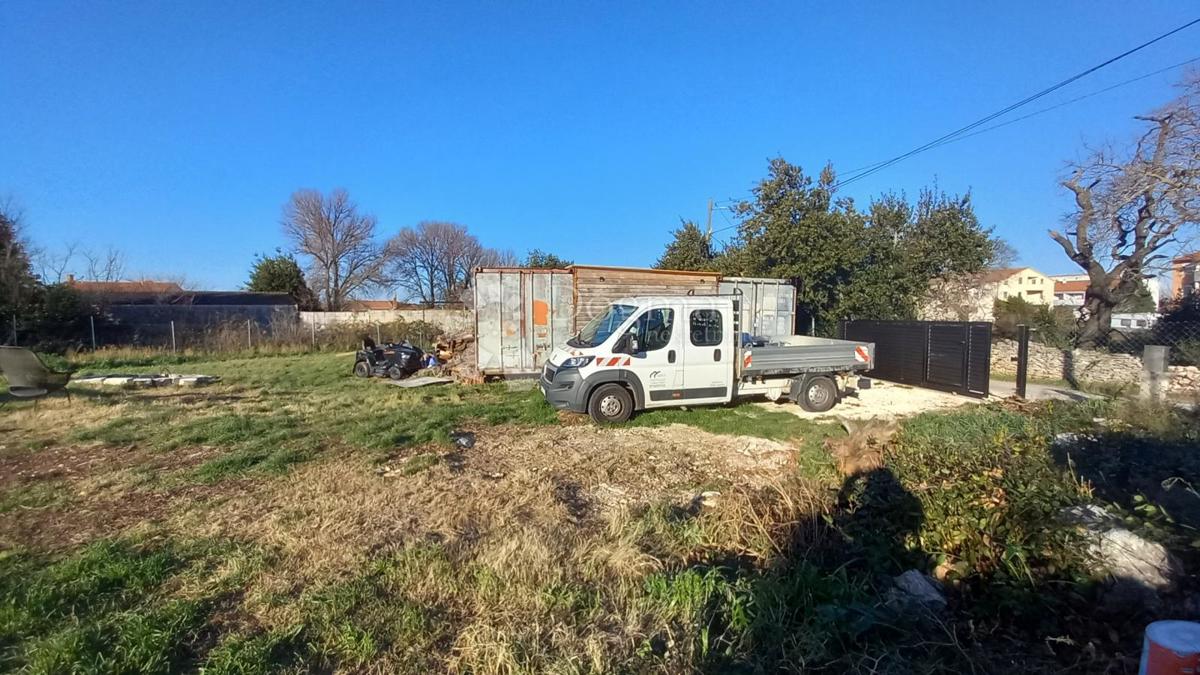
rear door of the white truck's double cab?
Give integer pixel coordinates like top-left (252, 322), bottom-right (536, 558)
top-left (680, 307), bottom-right (737, 404)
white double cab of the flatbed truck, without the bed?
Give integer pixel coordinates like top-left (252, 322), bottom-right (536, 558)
top-left (541, 295), bottom-right (738, 422)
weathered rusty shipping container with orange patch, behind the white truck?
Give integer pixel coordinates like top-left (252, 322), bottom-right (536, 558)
top-left (474, 265), bottom-right (796, 376)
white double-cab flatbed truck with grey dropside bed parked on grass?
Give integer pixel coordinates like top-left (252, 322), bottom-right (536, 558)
top-left (540, 295), bottom-right (875, 423)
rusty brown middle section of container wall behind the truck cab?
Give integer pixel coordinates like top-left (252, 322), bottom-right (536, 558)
top-left (572, 267), bottom-right (719, 330)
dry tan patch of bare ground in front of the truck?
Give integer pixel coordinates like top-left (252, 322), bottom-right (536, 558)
top-left (173, 425), bottom-right (794, 585)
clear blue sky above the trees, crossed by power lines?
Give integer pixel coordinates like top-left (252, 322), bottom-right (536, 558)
top-left (0, 0), bottom-right (1200, 288)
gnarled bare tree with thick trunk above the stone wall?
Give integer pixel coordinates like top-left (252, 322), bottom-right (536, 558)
top-left (1050, 74), bottom-right (1200, 347)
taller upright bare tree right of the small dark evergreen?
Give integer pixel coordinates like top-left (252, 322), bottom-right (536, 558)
top-left (283, 189), bottom-right (385, 310)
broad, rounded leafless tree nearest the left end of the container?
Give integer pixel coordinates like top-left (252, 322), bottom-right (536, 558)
top-left (388, 221), bottom-right (516, 306)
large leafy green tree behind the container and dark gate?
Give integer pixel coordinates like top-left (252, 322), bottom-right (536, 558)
top-left (715, 159), bottom-right (995, 333)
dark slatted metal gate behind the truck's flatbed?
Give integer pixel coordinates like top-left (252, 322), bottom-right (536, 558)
top-left (839, 321), bottom-right (991, 398)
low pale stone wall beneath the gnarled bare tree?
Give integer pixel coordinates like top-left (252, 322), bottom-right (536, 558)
top-left (991, 340), bottom-right (1200, 394)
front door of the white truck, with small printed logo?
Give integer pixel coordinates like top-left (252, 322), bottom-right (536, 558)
top-left (624, 307), bottom-right (684, 408)
